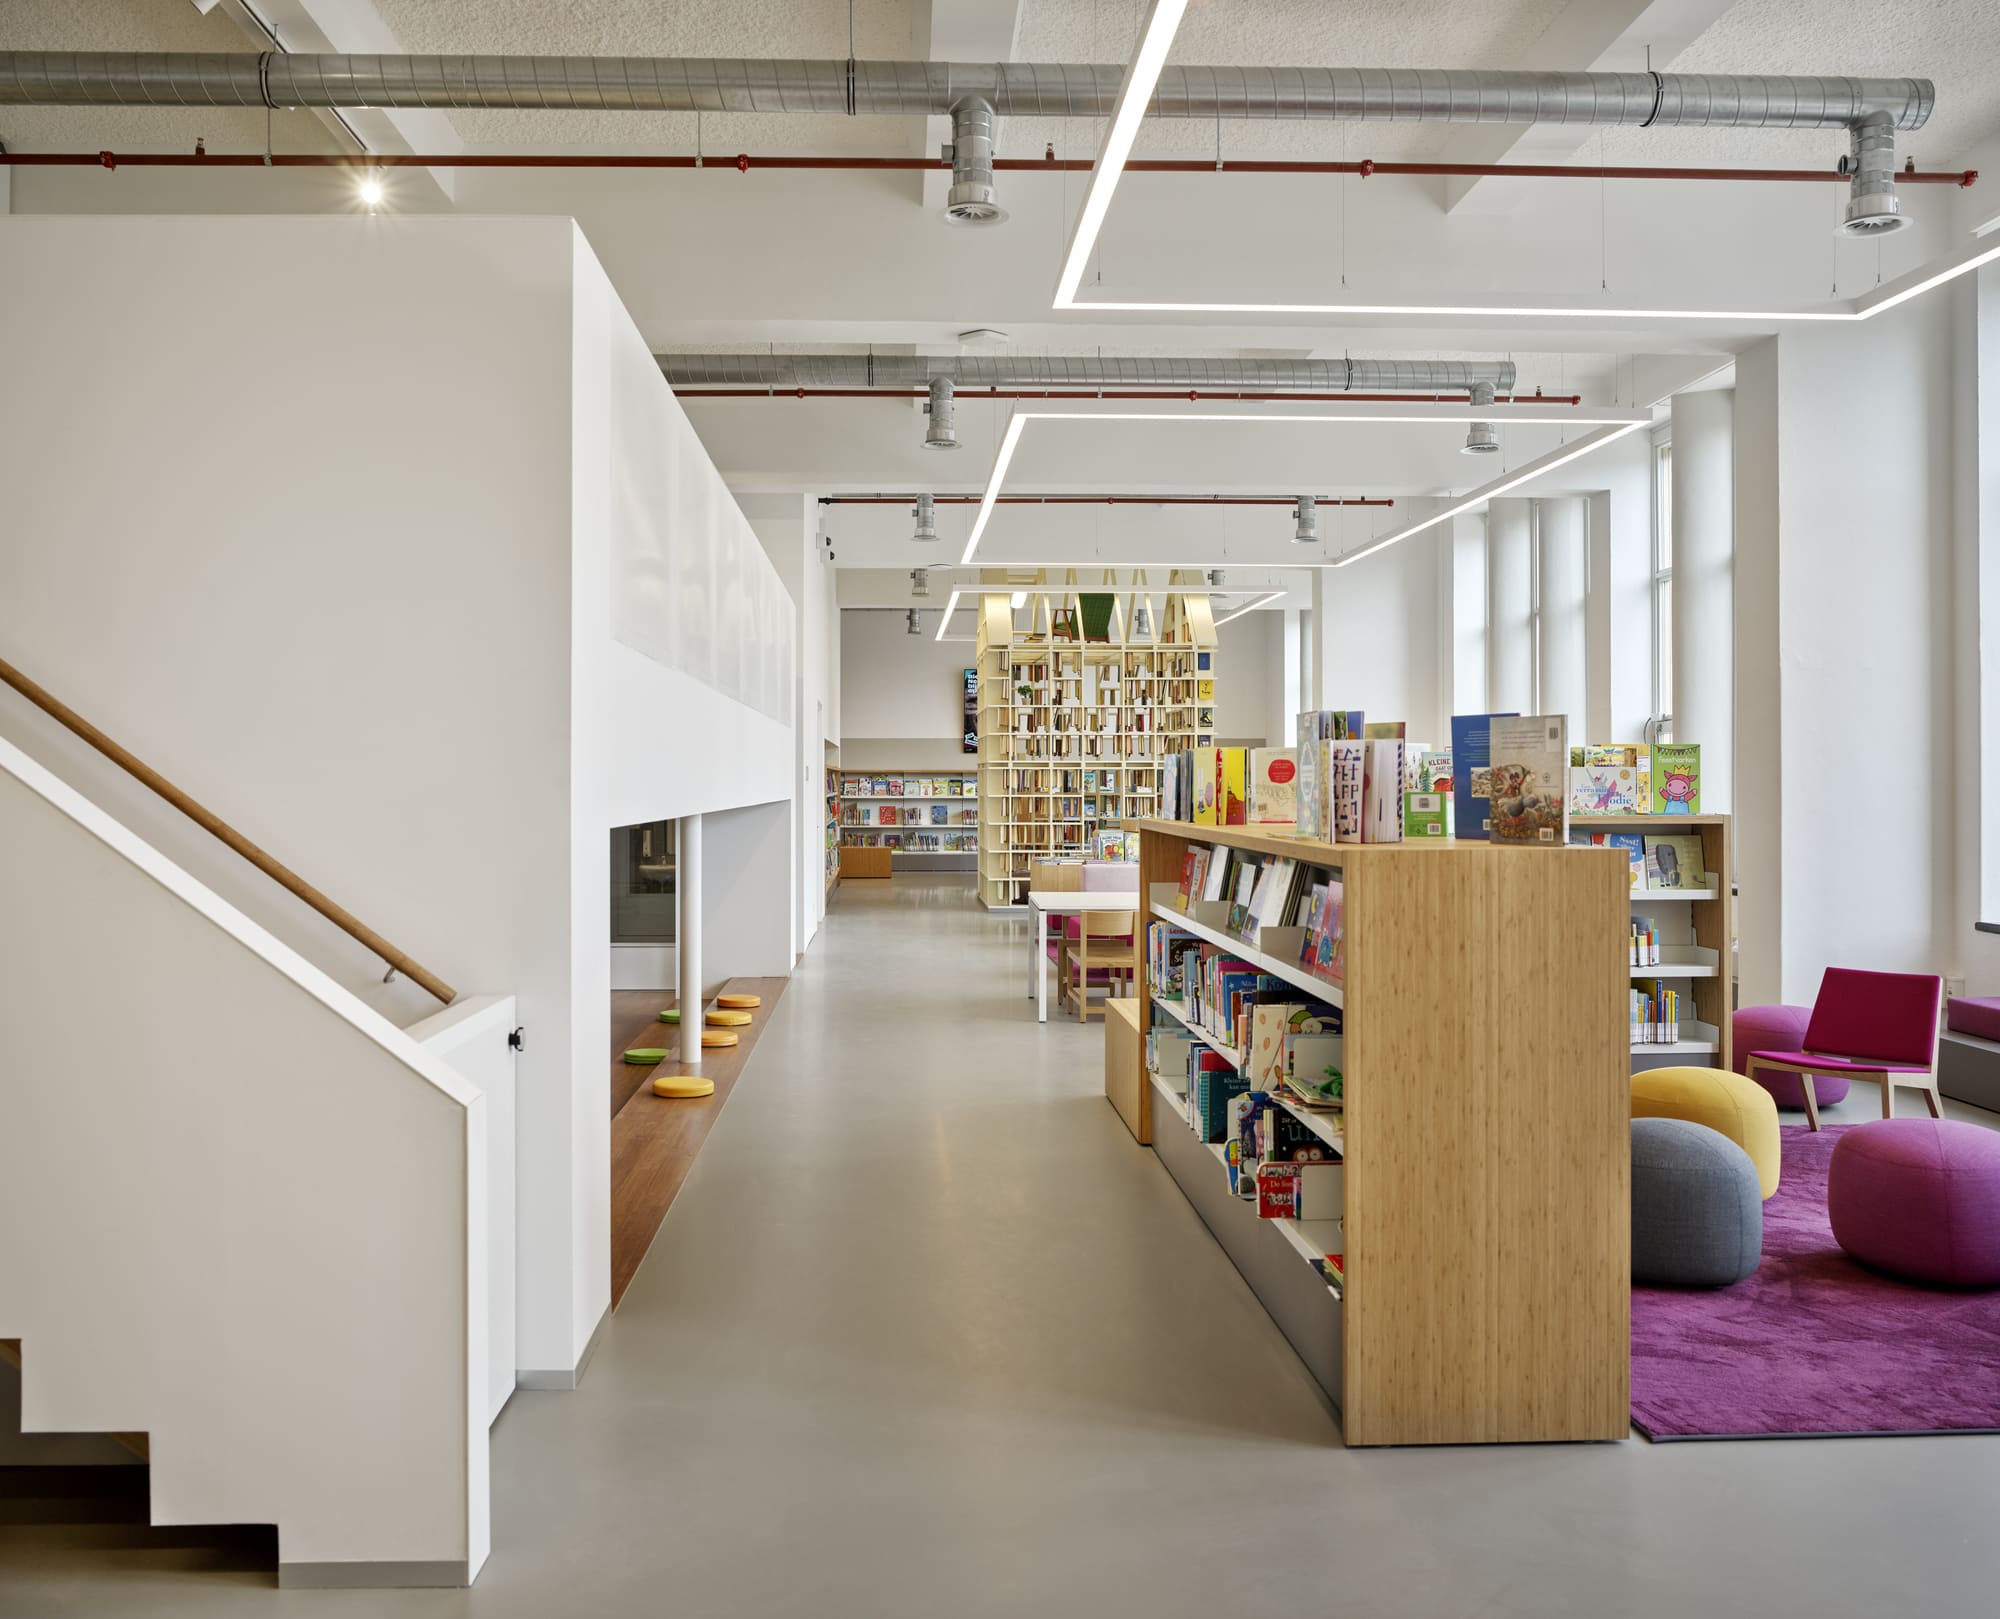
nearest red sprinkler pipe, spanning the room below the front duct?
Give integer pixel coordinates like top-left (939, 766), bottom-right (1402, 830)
top-left (0, 150), bottom-right (1980, 188)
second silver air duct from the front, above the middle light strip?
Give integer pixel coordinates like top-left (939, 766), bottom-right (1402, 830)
top-left (658, 354), bottom-right (1514, 391)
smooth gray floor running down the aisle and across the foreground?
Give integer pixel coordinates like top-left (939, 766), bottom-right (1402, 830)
top-left (11, 879), bottom-right (2000, 1619)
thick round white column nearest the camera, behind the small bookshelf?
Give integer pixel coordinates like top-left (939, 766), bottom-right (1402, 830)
top-left (1674, 388), bottom-right (1736, 811)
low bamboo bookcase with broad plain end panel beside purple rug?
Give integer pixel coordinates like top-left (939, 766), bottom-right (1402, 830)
top-left (1106, 819), bottom-right (1632, 1445)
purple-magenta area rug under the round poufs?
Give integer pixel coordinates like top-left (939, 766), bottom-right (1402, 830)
top-left (1632, 1125), bottom-right (2000, 1439)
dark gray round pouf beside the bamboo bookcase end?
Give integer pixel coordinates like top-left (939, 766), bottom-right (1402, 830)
top-left (1632, 1119), bottom-right (1764, 1287)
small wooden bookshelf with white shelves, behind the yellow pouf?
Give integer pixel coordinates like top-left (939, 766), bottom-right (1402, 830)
top-left (1570, 815), bottom-right (1736, 1067)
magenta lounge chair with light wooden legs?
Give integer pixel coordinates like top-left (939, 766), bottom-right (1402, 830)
top-left (1744, 967), bottom-right (1944, 1129)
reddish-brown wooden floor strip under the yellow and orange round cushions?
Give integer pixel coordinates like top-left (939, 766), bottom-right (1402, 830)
top-left (610, 977), bottom-right (786, 1309)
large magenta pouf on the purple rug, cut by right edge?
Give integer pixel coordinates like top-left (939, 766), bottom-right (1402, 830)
top-left (1826, 1119), bottom-right (2000, 1287)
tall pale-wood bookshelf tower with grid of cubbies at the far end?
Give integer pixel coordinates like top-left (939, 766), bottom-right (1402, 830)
top-left (978, 572), bottom-right (1216, 909)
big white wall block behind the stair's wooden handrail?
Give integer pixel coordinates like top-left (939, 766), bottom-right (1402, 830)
top-left (0, 216), bottom-right (792, 1383)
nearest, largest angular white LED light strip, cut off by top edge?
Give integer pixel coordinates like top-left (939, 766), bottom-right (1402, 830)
top-left (1056, 0), bottom-right (2000, 320)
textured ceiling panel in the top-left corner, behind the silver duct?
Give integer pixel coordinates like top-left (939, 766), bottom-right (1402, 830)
top-left (0, 0), bottom-right (340, 152)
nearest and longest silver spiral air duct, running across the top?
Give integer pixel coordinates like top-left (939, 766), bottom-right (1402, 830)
top-left (0, 50), bottom-right (1936, 130)
